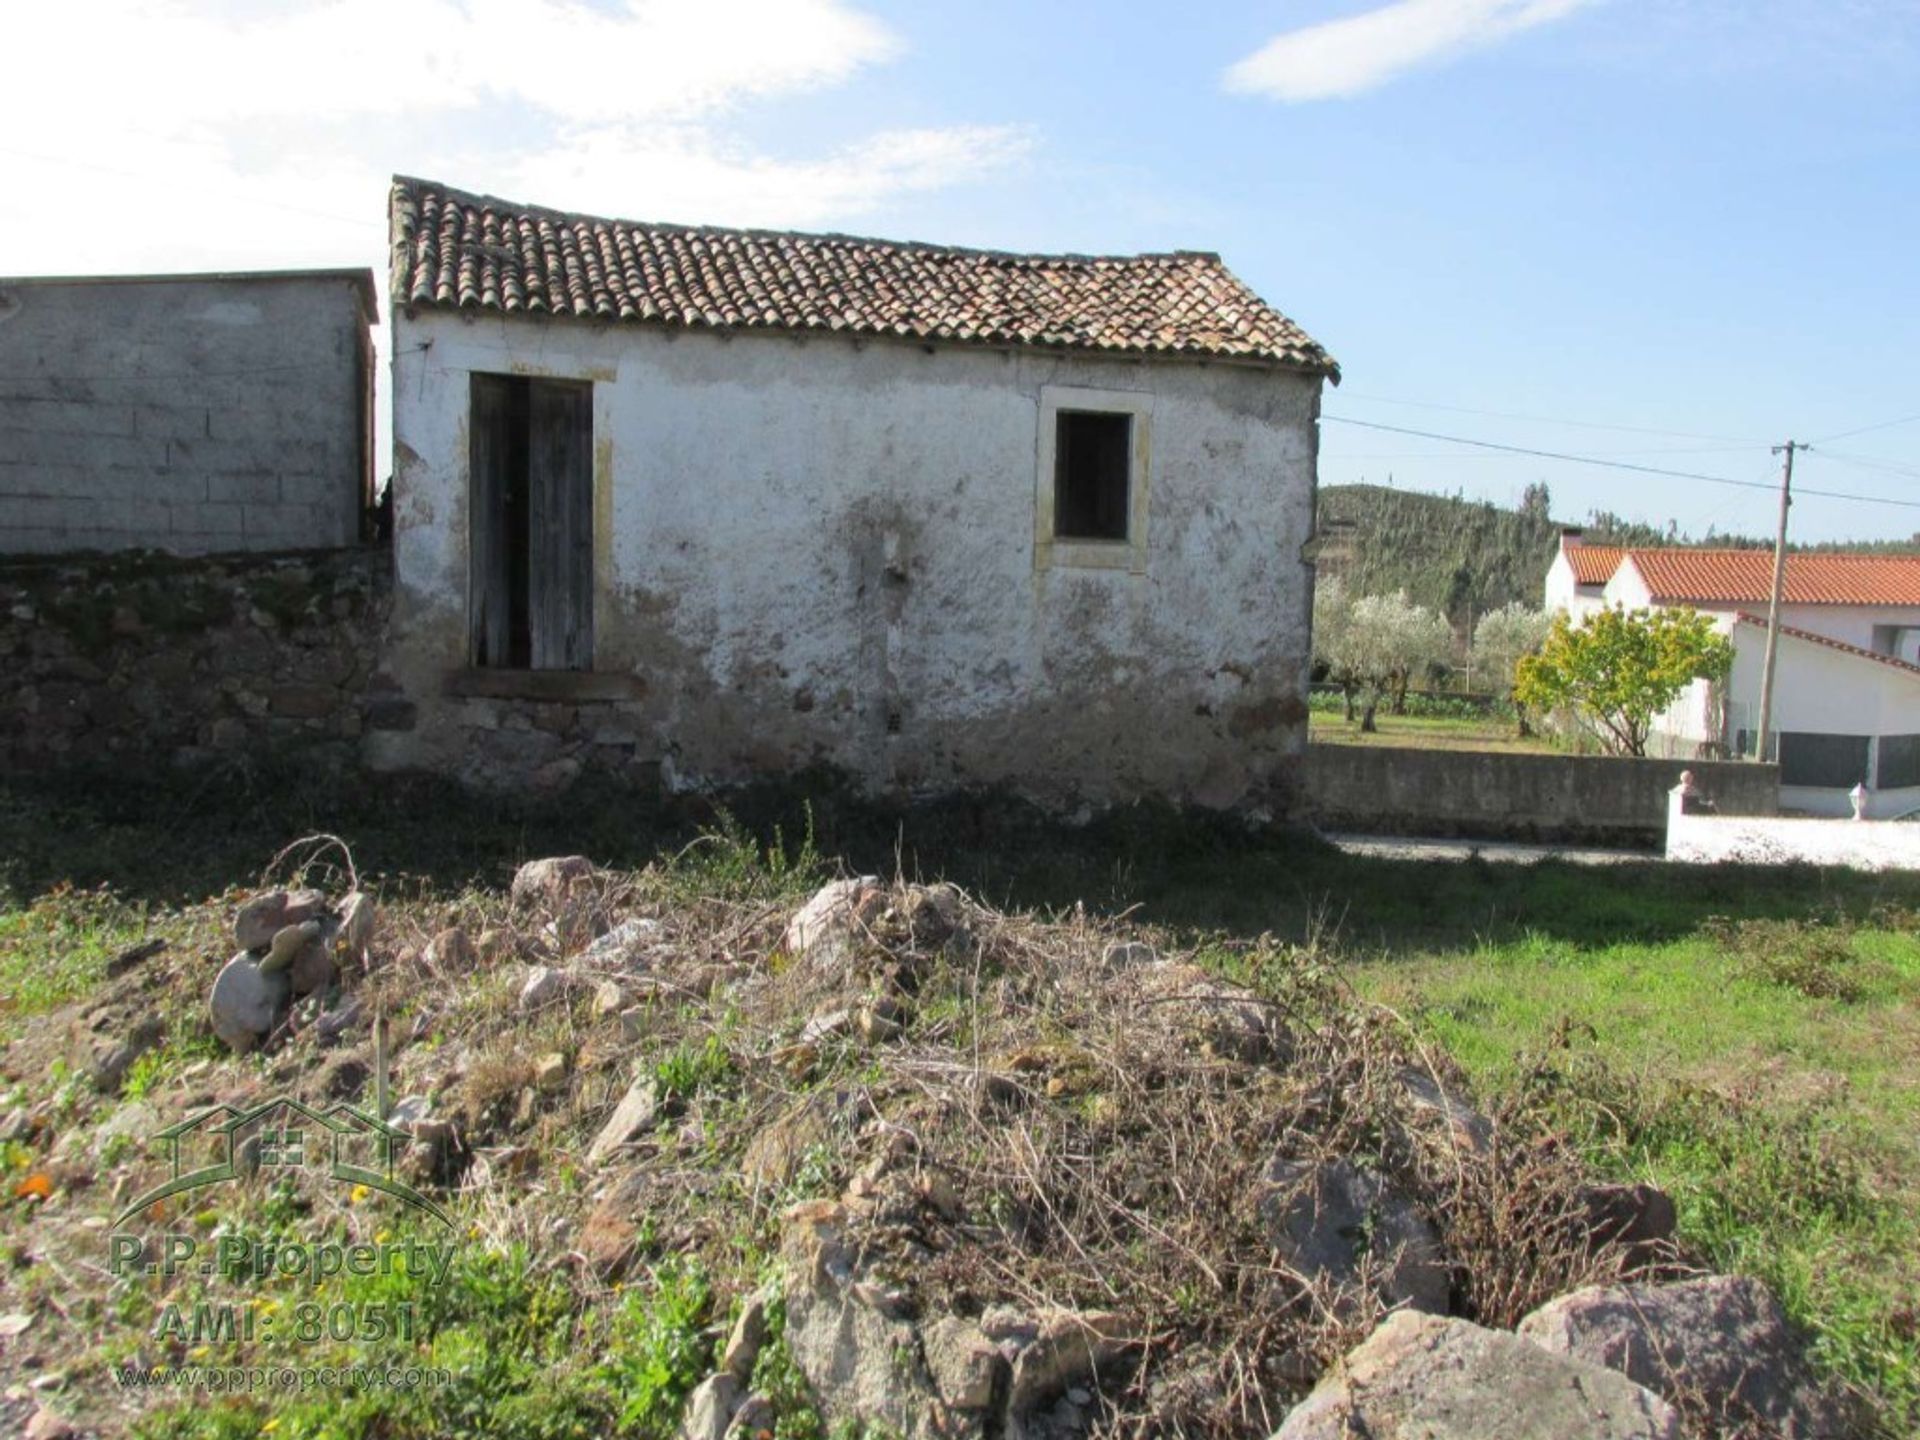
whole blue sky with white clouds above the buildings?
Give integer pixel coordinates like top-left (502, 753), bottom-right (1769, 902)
top-left (0, 0), bottom-right (1920, 540)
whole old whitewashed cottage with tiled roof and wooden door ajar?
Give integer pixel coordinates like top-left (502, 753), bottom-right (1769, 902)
top-left (369, 179), bottom-right (1338, 810)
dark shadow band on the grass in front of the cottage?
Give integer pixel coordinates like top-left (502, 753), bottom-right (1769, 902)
top-left (0, 764), bottom-right (1920, 952)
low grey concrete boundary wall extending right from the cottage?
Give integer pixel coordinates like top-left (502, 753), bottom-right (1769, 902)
top-left (1308, 745), bottom-right (1780, 849)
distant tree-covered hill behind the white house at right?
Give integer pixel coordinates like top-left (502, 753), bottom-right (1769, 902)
top-left (1319, 486), bottom-right (1920, 636)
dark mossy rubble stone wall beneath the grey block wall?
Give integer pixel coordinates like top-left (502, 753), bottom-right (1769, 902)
top-left (0, 549), bottom-right (389, 772)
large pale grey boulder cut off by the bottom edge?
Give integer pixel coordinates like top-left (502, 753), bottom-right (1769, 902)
top-left (1273, 1309), bottom-right (1682, 1440)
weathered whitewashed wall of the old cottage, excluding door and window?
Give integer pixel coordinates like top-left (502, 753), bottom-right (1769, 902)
top-left (372, 311), bottom-right (1319, 806)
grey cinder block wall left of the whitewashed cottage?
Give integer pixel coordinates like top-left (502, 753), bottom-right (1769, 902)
top-left (0, 269), bottom-right (378, 555)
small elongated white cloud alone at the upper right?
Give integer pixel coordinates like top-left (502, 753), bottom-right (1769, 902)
top-left (1225, 0), bottom-right (1594, 100)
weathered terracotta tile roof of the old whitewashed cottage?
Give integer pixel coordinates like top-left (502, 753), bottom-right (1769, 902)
top-left (390, 177), bottom-right (1340, 382)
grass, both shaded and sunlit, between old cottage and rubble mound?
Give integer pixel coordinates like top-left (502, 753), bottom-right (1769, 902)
top-left (11, 768), bottom-right (1920, 1434)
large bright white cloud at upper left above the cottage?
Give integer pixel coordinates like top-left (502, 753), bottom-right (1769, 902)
top-left (0, 0), bottom-right (1029, 273)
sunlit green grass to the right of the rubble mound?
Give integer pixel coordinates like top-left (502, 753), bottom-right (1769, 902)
top-left (1354, 910), bottom-right (1920, 1434)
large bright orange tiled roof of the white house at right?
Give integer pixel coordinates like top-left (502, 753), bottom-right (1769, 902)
top-left (1628, 549), bottom-right (1920, 605)
